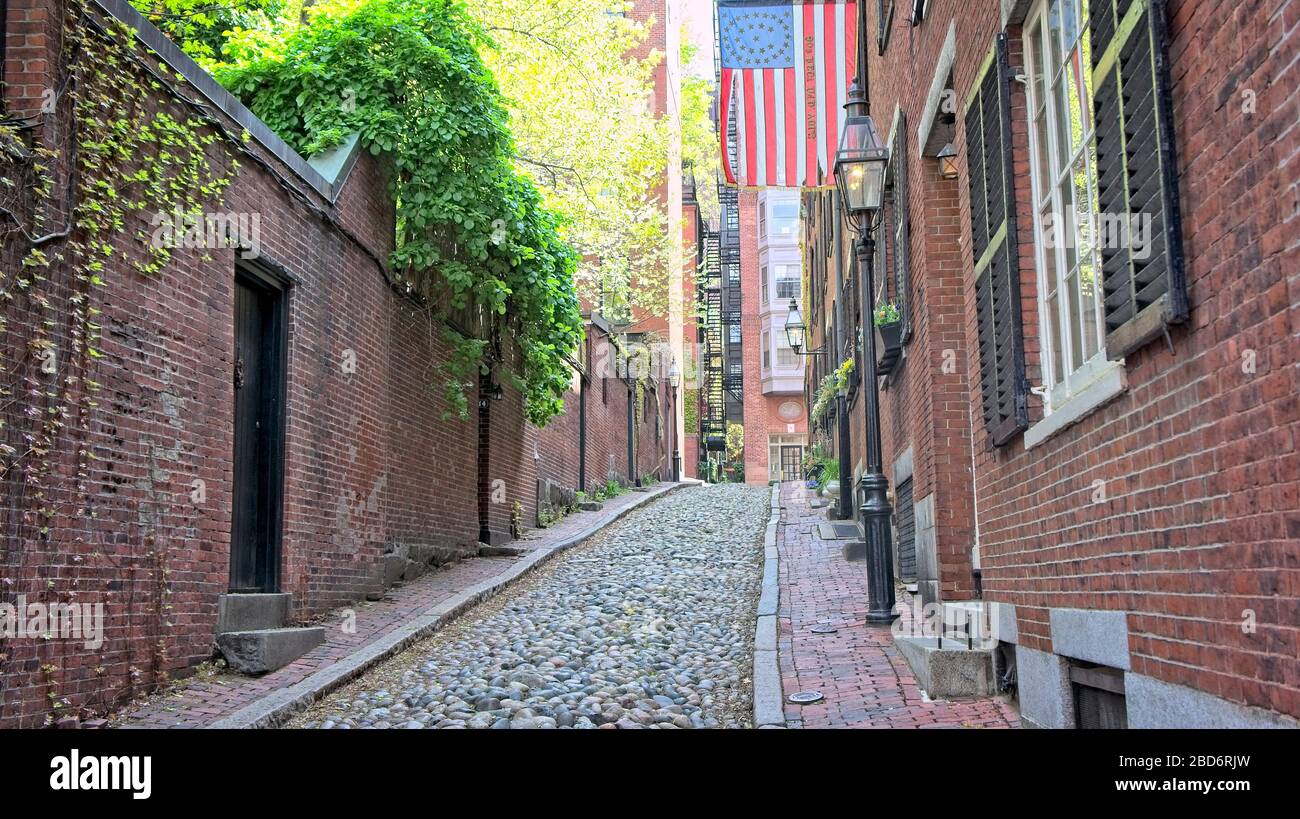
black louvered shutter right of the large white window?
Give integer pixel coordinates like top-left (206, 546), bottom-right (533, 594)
top-left (1089, 0), bottom-right (1188, 359)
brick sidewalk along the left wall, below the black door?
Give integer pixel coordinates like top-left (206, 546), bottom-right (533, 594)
top-left (112, 484), bottom-right (668, 728)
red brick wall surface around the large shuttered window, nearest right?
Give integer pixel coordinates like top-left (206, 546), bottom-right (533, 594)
top-left (927, 0), bottom-right (1300, 715)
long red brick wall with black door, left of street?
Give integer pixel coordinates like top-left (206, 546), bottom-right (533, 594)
top-left (0, 0), bottom-right (672, 725)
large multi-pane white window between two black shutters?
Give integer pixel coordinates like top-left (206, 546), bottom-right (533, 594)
top-left (1024, 0), bottom-right (1106, 412)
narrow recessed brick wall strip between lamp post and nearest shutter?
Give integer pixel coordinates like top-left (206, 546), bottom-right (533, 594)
top-left (845, 3), bottom-right (977, 601)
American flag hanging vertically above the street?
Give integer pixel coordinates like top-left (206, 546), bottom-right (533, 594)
top-left (718, 0), bottom-right (858, 187)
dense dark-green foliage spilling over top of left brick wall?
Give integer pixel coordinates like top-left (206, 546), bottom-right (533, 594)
top-left (165, 0), bottom-right (582, 425)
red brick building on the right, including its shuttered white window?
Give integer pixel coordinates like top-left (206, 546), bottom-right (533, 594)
top-left (805, 0), bottom-right (1300, 727)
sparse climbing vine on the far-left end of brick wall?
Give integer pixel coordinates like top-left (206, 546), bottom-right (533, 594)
top-left (0, 0), bottom-right (238, 712)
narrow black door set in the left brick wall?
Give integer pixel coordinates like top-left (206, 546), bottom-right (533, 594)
top-left (230, 274), bottom-right (285, 592)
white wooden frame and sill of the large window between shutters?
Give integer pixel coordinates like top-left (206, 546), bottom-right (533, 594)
top-left (1021, 0), bottom-right (1115, 413)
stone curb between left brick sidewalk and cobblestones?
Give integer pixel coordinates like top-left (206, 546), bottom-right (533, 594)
top-left (207, 484), bottom-right (686, 728)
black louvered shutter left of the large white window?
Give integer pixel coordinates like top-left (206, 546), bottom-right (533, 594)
top-left (965, 34), bottom-right (1030, 446)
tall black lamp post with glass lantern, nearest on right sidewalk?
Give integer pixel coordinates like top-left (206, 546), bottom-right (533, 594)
top-left (835, 82), bottom-right (897, 624)
